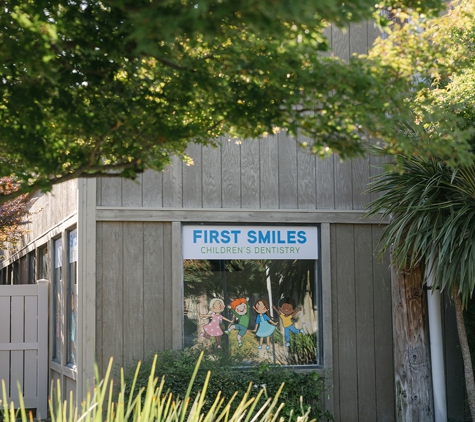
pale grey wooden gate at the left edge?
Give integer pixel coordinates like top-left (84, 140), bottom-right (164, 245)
top-left (0, 280), bottom-right (49, 419)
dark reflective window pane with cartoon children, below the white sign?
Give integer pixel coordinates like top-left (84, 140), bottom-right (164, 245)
top-left (184, 259), bottom-right (320, 365)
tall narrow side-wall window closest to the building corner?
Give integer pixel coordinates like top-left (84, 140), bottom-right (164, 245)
top-left (66, 229), bottom-right (78, 366)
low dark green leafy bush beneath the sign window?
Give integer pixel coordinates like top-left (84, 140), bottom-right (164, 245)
top-left (121, 348), bottom-right (333, 421)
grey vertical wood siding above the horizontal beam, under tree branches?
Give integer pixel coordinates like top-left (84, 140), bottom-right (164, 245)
top-left (97, 132), bottom-right (390, 210)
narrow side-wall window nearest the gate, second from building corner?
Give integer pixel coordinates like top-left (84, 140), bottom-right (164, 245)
top-left (53, 238), bottom-right (63, 362)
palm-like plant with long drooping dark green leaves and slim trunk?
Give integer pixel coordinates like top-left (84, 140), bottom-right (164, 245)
top-left (368, 157), bottom-right (475, 415)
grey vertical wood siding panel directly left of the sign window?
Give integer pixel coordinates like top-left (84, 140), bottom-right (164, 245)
top-left (96, 222), bottom-right (183, 371)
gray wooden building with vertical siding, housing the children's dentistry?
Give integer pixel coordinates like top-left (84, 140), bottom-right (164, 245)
top-left (0, 20), bottom-right (464, 422)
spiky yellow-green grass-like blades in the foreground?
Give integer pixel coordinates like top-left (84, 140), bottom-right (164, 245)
top-left (0, 354), bottom-right (328, 422)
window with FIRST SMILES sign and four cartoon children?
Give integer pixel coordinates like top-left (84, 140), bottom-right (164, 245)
top-left (183, 225), bottom-right (322, 365)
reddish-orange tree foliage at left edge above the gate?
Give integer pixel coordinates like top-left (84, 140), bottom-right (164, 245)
top-left (0, 177), bottom-right (31, 254)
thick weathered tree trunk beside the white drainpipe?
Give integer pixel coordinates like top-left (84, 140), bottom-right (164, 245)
top-left (391, 267), bottom-right (434, 422)
